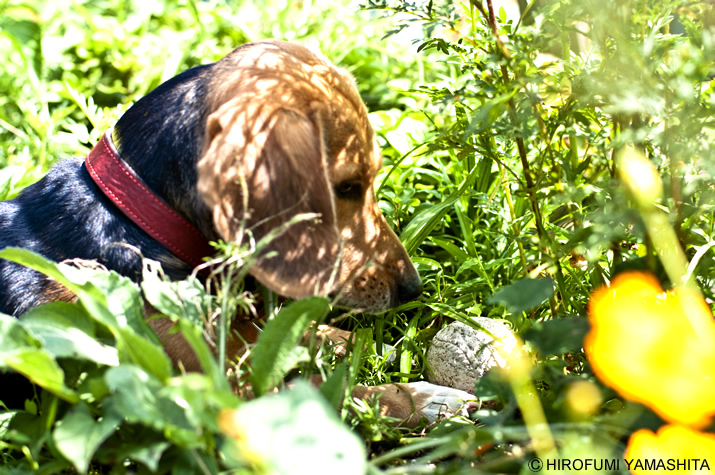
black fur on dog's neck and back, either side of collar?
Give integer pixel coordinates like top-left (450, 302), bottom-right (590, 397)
top-left (0, 61), bottom-right (224, 316)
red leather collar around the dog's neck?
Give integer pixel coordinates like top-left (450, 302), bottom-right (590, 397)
top-left (84, 131), bottom-right (215, 267)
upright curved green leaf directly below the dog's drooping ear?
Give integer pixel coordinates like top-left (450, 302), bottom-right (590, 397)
top-left (251, 297), bottom-right (329, 395)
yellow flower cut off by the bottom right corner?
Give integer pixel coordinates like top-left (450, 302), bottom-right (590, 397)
top-left (623, 425), bottom-right (715, 475)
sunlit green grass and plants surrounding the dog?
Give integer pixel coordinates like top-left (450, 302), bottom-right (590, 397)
top-left (0, 0), bottom-right (715, 473)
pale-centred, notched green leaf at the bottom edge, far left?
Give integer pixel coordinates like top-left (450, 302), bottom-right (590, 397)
top-left (52, 403), bottom-right (122, 473)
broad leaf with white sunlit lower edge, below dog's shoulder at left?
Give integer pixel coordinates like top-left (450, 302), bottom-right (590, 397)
top-left (21, 302), bottom-right (119, 366)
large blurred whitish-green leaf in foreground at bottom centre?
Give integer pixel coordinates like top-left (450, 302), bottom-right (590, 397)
top-left (220, 381), bottom-right (367, 475)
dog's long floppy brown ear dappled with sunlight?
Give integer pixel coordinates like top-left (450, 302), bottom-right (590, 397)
top-left (198, 98), bottom-right (339, 298)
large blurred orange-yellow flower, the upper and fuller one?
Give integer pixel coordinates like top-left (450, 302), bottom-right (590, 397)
top-left (584, 272), bottom-right (715, 427)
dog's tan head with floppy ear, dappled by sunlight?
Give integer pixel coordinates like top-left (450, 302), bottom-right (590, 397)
top-left (198, 41), bottom-right (422, 313)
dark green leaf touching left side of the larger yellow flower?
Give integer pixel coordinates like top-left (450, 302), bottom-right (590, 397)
top-left (524, 318), bottom-right (590, 358)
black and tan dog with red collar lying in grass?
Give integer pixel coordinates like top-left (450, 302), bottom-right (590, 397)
top-left (0, 40), bottom-right (482, 425)
